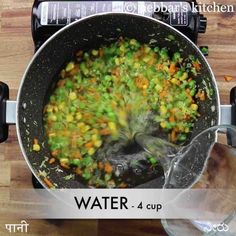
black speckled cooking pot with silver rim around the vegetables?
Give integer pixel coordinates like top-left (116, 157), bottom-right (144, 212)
top-left (0, 13), bottom-right (234, 188)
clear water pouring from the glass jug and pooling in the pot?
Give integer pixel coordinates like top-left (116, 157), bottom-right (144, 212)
top-left (97, 96), bottom-right (236, 189)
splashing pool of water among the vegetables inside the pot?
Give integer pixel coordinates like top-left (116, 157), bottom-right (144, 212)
top-left (97, 107), bottom-right (164, 188)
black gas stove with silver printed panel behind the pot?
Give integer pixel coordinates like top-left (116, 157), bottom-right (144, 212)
top-left (32, 0), bottom-right (207, 188)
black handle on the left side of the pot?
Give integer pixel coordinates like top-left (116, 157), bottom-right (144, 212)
top-left (0, 82), bottom-right (9, 143)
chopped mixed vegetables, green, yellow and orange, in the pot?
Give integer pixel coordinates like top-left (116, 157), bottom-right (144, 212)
top-left (43, 39), bottom-right (205, 187)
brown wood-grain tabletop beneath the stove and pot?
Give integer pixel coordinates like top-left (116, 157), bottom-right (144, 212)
top-left (0, 0), bottom-right (236, 236)
